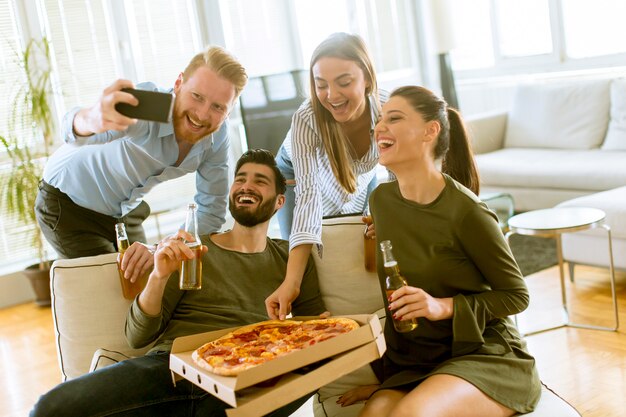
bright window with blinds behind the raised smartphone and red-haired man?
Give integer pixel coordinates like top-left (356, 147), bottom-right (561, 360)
top-left (43, 0), bottom-right (201, 110)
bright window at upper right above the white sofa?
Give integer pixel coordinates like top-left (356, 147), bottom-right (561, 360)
top-left (450, 0), bottom-right (626, 78)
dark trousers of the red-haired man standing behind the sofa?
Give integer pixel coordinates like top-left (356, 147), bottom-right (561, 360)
top-left (35, 180), bottom-right (150, 258)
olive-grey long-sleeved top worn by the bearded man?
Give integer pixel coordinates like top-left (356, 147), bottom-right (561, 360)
top-left (126, 236), bottom-right (325, 352)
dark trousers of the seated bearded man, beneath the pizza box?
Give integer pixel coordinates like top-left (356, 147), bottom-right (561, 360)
top-left (30, 352), bottom-right (310, 417)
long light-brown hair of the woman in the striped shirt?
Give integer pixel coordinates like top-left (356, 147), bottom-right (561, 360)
top-left (309, 32), bottom-right (380, 194)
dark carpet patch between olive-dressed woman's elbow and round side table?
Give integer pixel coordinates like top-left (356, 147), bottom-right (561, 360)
top-left (509, 235), bottom-right (558, 276)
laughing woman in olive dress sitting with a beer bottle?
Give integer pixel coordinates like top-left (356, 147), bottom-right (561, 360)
top-left (339, 86), bottom-right (541, 417)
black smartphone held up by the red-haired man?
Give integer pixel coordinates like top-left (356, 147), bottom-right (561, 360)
top-left (115, 88), bottom-right (174, 123)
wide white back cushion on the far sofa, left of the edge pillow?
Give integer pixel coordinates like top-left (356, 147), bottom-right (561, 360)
top-left (504, 80), bottom-right (610, 149)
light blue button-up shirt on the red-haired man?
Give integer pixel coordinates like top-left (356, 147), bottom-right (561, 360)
top-left (43, 83), bottom-right (230, 234)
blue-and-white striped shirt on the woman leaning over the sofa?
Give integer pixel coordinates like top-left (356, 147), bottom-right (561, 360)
top-left (283, 91), bottom-right (387, 253)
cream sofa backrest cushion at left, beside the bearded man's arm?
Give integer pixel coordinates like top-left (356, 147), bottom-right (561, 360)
top-left (50, 253), bottom-right (148, 380)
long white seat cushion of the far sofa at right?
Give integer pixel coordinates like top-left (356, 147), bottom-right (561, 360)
top-left (476, 148), bottom-right (626, 192)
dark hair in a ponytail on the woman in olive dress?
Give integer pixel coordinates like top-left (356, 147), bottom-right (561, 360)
top-left (390, 86), bottom-right (480, 195)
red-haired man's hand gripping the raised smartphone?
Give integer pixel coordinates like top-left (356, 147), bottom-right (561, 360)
top-left (72, 79), bottom-right (139, 136)
